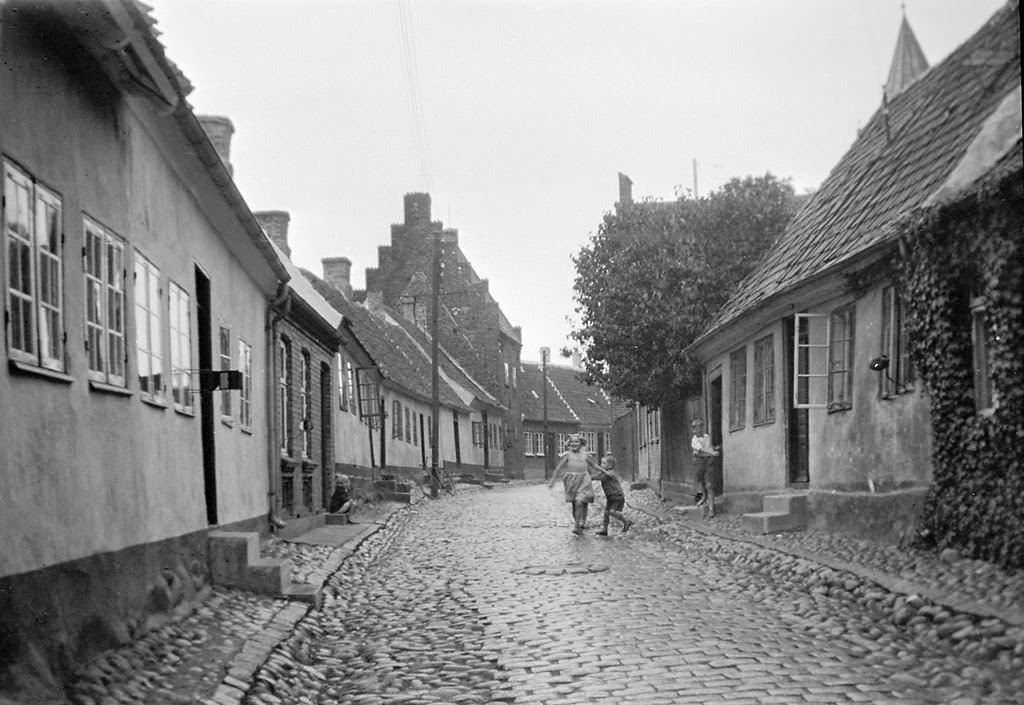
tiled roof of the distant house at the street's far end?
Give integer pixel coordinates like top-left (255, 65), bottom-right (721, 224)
top-left (519, 362), bottom-right (625, 427)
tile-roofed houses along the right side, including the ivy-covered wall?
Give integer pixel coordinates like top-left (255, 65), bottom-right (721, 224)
top-left (616, 0), bottom-right (1024, 549)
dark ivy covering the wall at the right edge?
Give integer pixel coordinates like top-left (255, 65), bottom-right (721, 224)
top-left (899, 172), bottom-right (1024, 568)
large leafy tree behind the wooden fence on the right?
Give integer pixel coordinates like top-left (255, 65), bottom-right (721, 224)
top-left (571, 174), bottom-right (798, 407)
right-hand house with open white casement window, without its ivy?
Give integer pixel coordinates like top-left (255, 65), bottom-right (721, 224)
top-left (692, 3), bottom-right (1020, 538)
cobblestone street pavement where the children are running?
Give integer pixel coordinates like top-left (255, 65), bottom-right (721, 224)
top-left (71, 485), bottom-right (1024, 705)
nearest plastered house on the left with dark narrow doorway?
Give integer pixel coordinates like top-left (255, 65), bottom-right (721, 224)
top-left (0, 0), bottom-right (288, 689)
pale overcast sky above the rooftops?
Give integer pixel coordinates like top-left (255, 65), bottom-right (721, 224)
top-left (147, 0), bottom-right (1004, 363)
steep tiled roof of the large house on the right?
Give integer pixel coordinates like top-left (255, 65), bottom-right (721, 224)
top-left (700, 0), bottom-right (1021, 340)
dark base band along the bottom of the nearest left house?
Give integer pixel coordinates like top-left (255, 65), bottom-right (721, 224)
top-left (0, 514), bottom-right (268, 702)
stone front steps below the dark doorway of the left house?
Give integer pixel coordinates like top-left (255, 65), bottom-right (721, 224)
top-left (209, 531), bottom-right (319, 604)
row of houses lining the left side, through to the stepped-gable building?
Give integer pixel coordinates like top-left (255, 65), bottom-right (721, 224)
top-left (0, 0), bottom-right (544, 692)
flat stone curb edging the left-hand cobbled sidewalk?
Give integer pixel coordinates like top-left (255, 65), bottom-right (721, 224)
top-left (205, 506), bottom-right (406, 705)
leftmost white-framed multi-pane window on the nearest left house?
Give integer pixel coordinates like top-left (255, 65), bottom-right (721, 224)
top-left (4, 163), bottom-right (65, 371)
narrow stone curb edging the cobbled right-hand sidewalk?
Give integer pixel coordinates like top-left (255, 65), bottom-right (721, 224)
top-left (651, 512), bottom-right (1024, 627)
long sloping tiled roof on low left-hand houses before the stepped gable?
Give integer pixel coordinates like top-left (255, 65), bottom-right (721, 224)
top-left (301, 269), bottom-right (470, 412)
